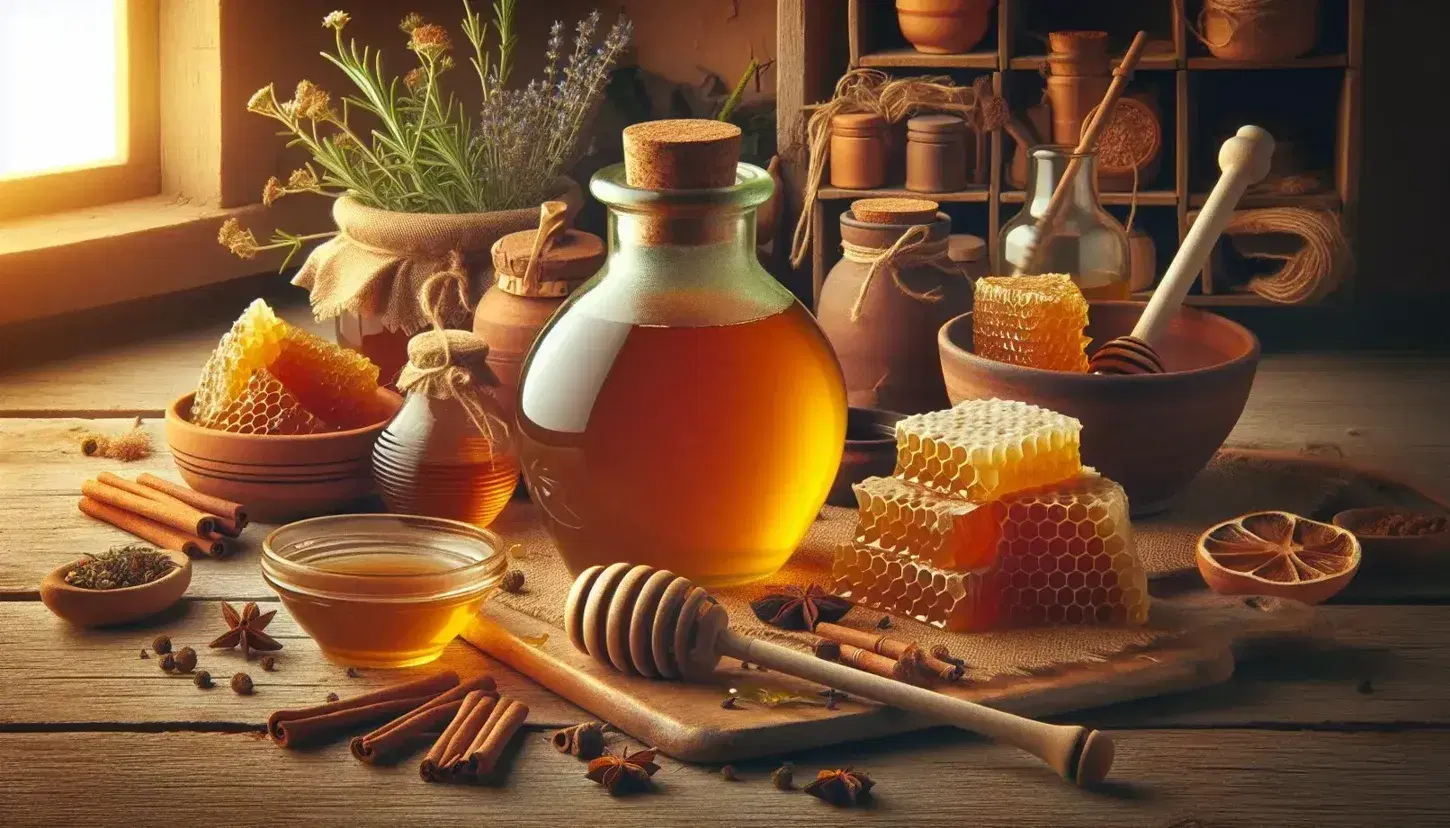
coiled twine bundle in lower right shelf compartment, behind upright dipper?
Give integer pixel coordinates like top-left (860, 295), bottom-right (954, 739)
top-left (1224, 207), bottom-right (1353, 305)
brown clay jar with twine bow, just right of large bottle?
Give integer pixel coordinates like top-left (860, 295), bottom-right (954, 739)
top-left (816, 199), bottom-right (972, 413)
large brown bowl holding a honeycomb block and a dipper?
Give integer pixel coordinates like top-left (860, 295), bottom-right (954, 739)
top-left (937, 302), bottom-right (1259, 515)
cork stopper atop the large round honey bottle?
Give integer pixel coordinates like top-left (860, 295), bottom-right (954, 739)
top-left (624, 119), bottom-right (741, 190)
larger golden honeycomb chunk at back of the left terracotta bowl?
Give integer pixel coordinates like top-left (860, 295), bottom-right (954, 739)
top-left (191, 299), bottom-right (387, 434)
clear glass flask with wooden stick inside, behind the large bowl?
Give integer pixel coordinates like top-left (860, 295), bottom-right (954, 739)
top-left (998, 146), bottom-right (1131, 299)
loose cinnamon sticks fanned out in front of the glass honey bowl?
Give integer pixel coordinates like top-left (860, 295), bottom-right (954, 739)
top-left (267, 670), bottom-right (529, 782)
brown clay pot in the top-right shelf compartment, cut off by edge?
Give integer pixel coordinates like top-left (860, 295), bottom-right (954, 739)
top-left (1199, 0), bottom-right (1320, 61)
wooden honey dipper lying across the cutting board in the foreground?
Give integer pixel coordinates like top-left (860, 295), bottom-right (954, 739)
top-left (564, 564), bottom-right (1114, 787)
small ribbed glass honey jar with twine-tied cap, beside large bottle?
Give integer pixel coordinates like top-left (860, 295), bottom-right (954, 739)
top-left (373, 331), bottom-right (519, 528)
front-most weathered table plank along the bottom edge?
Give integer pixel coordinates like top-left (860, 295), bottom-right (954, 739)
top-left (0, 729), bottom-right (1450, 828)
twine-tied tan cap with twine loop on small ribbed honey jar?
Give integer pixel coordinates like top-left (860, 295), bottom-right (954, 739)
top-left (397, 271), bottom-right (509, 442)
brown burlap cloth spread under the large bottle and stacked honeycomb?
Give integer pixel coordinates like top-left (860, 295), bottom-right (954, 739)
top-left (490, 454), bottom-right (1347, 682)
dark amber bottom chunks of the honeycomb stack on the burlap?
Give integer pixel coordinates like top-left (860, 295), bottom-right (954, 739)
top-left (832, 471), bottom-right (1148, 632)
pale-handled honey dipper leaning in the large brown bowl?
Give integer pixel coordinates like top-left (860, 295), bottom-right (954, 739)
top-left (1088, 126), bottom-right (1273, 374)
